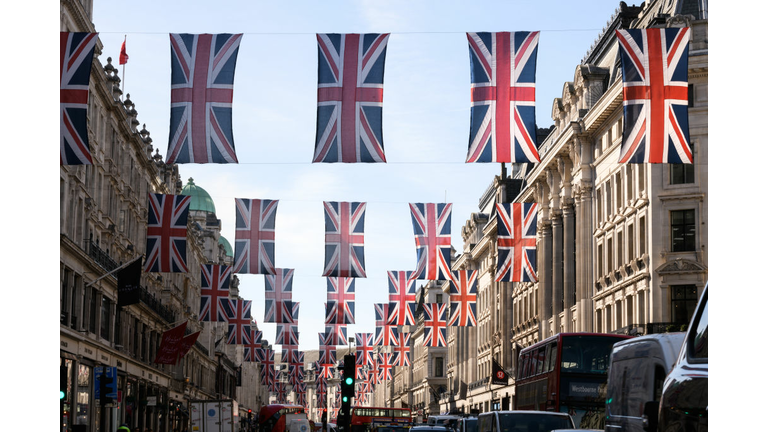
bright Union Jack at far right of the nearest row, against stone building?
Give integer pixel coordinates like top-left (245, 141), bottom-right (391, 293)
top-left (616, 27), bottom-right (693, 163)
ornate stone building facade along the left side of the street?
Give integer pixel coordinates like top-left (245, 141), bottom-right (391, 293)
top-left (59, 0), bottom-right (260, 432)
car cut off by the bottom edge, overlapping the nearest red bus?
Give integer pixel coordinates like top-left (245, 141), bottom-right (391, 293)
top-left (477, 411), bottom-right (576, 432)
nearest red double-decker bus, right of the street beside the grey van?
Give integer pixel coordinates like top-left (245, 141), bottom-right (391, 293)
top-left (514, 333), bottom-right (630, 429)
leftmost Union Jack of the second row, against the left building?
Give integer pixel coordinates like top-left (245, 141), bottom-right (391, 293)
top-left (144, 193), bottom-right (192, 273)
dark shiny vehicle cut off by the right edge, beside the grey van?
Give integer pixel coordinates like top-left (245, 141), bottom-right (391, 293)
top-left (649, 286), bottom-right (709, 432)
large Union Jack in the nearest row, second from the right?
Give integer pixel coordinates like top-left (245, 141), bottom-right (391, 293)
top-left (467, 32), bottom-right (540, 163)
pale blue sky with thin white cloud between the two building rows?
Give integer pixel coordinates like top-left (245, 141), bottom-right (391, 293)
top-left (87, 0), bottom-right (640, 349)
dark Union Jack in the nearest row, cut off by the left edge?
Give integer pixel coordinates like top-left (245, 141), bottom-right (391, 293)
top-left (59, 32), bottom-right (99, 165)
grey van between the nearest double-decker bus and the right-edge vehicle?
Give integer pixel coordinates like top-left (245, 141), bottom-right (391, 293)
top-left (605, 332), bottom-right (685, 432)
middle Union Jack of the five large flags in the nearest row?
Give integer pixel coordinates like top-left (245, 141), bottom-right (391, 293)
top-left (312, 33), bottom-right (389, 162)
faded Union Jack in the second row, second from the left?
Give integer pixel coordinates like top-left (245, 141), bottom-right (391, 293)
top-left (234, 198), bottom-right (278, 275)
